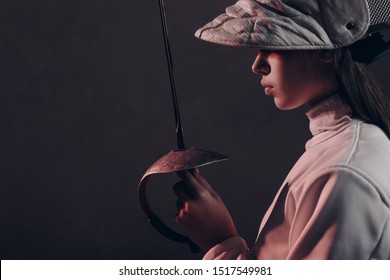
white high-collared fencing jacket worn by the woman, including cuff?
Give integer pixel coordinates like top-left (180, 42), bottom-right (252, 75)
top-left (203, 95), bottom-right (390, 260)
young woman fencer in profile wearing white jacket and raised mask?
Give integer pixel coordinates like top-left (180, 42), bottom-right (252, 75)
top-left (174, 0), bottom-right (390, 259)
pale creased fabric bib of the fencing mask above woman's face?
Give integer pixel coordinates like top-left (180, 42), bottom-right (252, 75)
top-left (195, 0), bottom-right (370, 50)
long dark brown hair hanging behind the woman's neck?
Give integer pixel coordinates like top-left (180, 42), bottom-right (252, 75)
top-left (335, 48), bottom-right (390, 139)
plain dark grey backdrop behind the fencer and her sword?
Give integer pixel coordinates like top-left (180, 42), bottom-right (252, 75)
top-left (0, 0), bottom-right (390, 259)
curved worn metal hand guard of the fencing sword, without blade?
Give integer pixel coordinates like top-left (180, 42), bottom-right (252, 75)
top-left (138, 148), bottom-right (228, 252)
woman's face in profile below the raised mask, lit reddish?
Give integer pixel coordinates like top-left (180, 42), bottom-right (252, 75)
top-left (252, 50), bottom-right (337, 110)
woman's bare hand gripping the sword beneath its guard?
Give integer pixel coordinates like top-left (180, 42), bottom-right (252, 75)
top-left (173, 170), bottom-right (238, 250)
